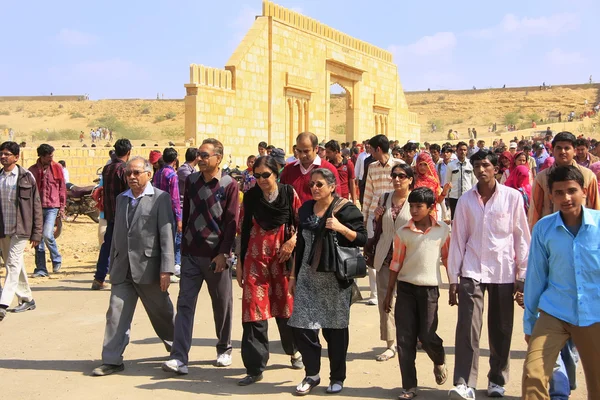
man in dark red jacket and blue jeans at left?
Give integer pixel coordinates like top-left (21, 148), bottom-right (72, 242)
top-left (29, 144), bottom-right (67, 278)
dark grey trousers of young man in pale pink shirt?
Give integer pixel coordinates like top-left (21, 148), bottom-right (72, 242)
top-left (454, 278), bottom-right (515, 388)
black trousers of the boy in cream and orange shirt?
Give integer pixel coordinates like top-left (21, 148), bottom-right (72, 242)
top-left (394, 282), bottom-right (446, 390)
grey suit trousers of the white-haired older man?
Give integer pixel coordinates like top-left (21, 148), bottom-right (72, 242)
top-left (102, 277), bottom-right (174, 365)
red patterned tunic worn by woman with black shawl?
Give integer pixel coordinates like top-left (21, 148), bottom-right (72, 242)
top-left (240, 192), bottom-right (302, 322)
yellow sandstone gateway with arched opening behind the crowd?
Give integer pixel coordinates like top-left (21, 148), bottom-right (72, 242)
top-left (185, 1), bottom-right (420, 165)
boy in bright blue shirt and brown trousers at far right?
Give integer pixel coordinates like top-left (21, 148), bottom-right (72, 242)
top-left (522, 165), bottom-right (600, 400)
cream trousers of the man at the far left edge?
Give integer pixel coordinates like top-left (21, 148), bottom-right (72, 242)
top-left (0, 236), bottom-right (33, 306)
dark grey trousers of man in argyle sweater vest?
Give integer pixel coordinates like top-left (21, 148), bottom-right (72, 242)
top-left (171, 255), bottom-right (233, 365)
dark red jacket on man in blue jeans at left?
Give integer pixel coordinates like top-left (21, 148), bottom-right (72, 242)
top-left (29, 158), bottom-right (67, 210)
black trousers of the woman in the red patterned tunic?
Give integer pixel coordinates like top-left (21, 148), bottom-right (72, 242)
top-left (242, 318), bottom-right (298, 376)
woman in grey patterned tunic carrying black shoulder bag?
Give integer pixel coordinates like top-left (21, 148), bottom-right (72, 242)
top-left (289, 168), bottom-right (367, 396)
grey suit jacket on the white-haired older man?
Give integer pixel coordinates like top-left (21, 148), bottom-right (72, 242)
top-left (109, 186), bottom-right (175, 284)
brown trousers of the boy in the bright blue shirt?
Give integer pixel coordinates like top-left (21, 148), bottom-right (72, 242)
top-left (522, 311), bottom-right (600, 400)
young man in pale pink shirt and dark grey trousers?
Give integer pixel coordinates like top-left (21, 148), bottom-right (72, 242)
top-left (447, 151), bottom-right (530, 400)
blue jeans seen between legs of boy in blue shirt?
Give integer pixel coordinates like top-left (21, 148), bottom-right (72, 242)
top-left (550, 339), bottom-right (579, 400)
